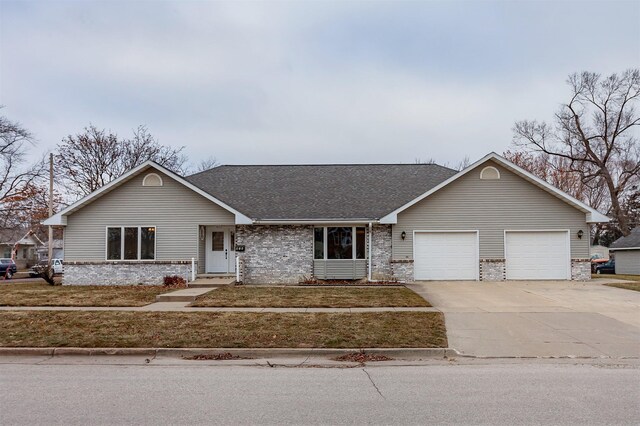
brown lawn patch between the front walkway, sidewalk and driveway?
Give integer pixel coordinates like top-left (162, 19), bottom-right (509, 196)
top-left (191, 286), bottom-right (431, 308)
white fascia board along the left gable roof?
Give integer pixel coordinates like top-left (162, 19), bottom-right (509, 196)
top-left (42, 160), bottom-right (253, 226)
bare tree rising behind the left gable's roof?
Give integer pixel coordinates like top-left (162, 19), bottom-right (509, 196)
top-left (55, 125), bottom-right (186, 198)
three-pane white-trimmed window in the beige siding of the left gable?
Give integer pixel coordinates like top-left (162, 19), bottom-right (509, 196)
top-left (107, 226), bottom-right (156, 260)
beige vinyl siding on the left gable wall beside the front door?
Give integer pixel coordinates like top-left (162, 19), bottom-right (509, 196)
top-left (64, 168), bottom-right (235, 262)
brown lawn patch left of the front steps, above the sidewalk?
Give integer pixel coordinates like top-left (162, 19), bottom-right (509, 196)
top-left (0, 283), bottom-right (171, 306)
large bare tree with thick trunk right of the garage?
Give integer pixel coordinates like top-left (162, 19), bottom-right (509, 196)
top-left (513, 69), bottom-right (640, 235)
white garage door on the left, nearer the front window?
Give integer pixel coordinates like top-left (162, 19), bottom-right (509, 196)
top-left (414, 232), bottom-right (479, 280)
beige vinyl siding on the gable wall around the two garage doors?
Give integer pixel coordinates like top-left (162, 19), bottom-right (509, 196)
top-left (393, 161), bottom-right (589, 260)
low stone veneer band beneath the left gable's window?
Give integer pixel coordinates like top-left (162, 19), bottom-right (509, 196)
top-left (62, 261), bottom-right (191, 285)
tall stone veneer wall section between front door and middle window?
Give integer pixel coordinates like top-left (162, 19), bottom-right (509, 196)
top-left (236, 225), bottom-right (313, 284)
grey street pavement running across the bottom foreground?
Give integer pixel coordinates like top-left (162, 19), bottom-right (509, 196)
top-left (0, 357), bottom-right (640, 425)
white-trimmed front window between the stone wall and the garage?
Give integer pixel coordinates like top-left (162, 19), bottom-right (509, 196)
top-left (313, 226), bottom-right (367, 260)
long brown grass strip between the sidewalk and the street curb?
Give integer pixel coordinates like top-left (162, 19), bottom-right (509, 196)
top-left (0, 311), bottom-right (447, 348)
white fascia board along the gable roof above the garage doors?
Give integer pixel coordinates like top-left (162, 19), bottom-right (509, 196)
top-left (380, 152), bottom-right (610, 224)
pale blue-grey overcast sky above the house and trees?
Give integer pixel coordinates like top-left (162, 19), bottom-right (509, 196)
top-left (0, 0), bottom-right (640, 168)
